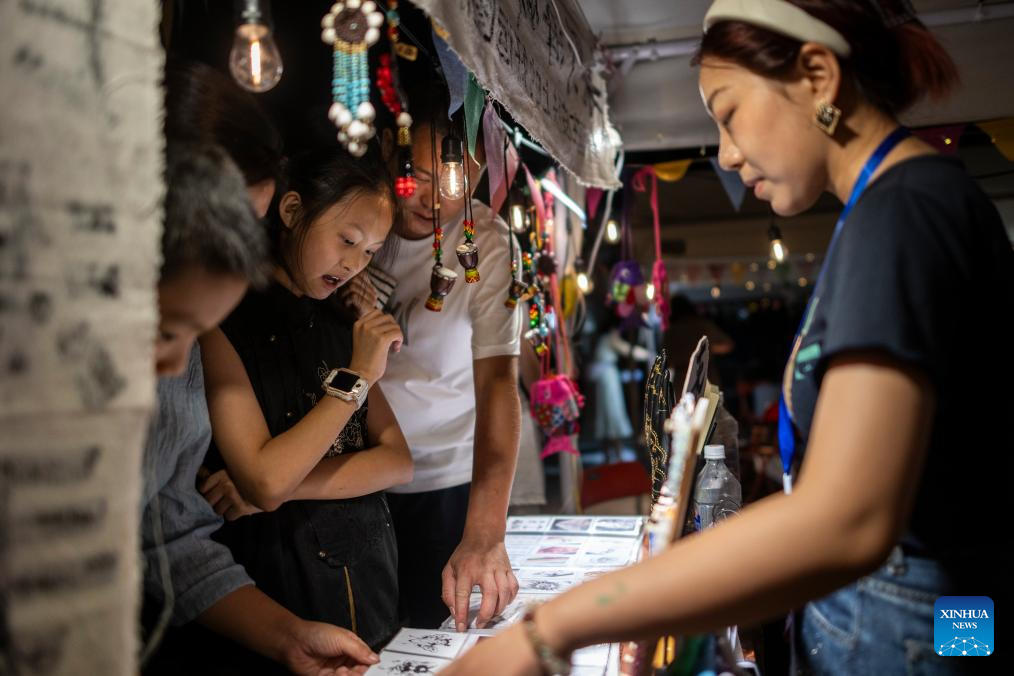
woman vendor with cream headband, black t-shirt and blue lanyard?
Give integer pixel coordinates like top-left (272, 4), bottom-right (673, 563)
top-left (442, 0), bottom-right (1014, 675)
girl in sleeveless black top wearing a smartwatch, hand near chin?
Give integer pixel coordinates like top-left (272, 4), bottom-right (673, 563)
top-left (201, 142), bottom-right (412, 647)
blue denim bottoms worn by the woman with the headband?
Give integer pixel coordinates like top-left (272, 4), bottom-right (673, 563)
top-left (793, 547), bottom-right (1000, 676)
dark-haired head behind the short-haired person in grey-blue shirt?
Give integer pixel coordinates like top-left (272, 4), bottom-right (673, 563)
top-left (165, 61), bottom-right (282, 217)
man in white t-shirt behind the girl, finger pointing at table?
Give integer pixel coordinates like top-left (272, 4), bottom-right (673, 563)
top-left (369, 80), bottom-right (521, 628)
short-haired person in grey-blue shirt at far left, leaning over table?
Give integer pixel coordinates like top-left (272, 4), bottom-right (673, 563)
top-left (141, 67), bottom-right (376, 675)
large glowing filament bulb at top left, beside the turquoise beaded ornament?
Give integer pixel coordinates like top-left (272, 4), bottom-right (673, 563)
top-left (229, 0), bottom-right (282, 92)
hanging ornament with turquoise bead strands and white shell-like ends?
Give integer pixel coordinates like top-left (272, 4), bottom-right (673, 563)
top-left (320, 0), bottom-right (383, 157)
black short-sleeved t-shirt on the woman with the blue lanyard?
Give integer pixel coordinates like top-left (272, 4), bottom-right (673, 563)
top-left (785, 155), bottom-right (1014, 557)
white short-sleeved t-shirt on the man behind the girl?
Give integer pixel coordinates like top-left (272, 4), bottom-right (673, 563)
top-left (381, 201), bottom-right (521, 493)
